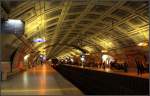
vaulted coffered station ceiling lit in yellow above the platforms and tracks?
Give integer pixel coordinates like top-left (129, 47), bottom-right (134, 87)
top-left (2, 0), bottom-right (149, 57)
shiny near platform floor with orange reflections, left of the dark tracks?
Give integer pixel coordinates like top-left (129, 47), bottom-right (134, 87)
top-left (1, 65), bottom-right (83, 96)
